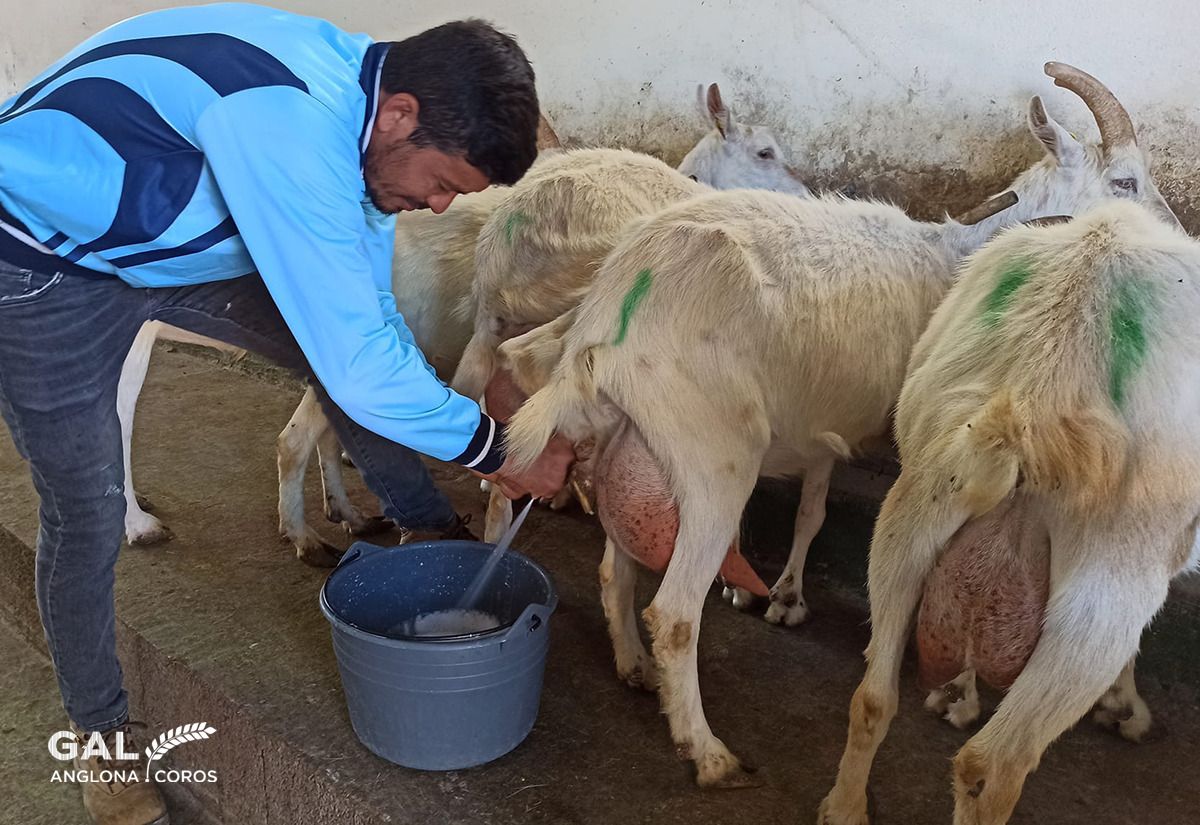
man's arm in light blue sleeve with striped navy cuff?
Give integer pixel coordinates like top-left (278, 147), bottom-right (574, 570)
top-left (196, 88), bottom-right (503, 474)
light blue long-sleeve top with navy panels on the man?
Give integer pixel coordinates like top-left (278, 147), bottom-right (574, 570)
top-left (0, 4), bottom-right (503, 471)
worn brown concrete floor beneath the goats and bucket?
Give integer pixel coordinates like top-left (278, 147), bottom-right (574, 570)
top-left (0, 351), bottom-right (1200, 825)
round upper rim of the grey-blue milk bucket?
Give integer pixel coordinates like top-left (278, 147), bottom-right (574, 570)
top-left (317, 538), bottom-right (558, 649)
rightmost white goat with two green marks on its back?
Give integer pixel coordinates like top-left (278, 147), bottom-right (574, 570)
top-left (821, 197), bottom-right (1200, 825)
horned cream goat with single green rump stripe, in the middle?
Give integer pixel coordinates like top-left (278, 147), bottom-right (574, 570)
top-left (508, 64), bottom-right (1160, 787)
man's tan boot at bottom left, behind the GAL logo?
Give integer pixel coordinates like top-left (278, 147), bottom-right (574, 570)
top-left (71, 722), bottom-right (169, 825)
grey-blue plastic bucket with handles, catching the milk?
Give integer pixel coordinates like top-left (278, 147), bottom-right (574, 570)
top-left (320, 541), bottom-right (558, 771)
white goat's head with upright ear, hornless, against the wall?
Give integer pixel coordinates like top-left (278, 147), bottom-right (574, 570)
top-left (679, 83), bottom-right (810, 197)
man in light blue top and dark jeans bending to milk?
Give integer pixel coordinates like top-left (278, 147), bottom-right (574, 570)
top-left (0, 5), bottom-right (572, 825)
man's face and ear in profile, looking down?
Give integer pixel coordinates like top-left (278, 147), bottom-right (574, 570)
top-left (362, 92), bottom-right (491, 215)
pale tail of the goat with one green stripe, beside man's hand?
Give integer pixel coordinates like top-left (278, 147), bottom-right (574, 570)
top-left (505, 349), bottom-right (596, 468)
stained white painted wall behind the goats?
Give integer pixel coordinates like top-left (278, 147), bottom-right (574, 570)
top-left (0, 0), bottom-right (1200, 223)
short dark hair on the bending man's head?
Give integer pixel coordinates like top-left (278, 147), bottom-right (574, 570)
top-left (379, 19), bottom-right (539, 185)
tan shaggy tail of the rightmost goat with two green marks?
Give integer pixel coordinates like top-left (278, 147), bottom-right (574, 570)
top-left (955, 390), bottom-right (1129, 516)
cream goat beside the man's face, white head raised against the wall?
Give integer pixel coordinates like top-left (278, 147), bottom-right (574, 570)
top-left (452, 91), bottom-right (809, 541)
